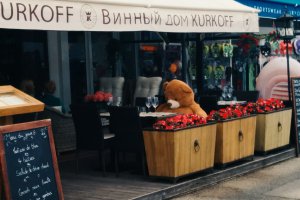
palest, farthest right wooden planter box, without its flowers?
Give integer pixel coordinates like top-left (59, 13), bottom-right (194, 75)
top-left (255, 108), bottom-right (292, 152)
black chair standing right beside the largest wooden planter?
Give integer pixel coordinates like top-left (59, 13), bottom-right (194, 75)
top-left (108, 106), bottom-right (146, 176)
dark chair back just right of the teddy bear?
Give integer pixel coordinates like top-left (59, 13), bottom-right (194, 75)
top-left (197, 95), bottom-right (219, 114)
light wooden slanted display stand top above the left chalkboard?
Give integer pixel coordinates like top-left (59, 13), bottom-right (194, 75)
top-left (0, 85), bottom-right (45, 117)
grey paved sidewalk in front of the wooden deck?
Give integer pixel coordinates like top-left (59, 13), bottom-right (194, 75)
top-left (173, 158), bottom-right (300, 200)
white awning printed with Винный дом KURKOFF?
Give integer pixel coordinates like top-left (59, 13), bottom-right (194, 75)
top-left (0, 0), bottom-right (259, 33)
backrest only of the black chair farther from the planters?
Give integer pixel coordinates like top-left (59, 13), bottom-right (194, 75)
top-left (70, 103), bottom-right (104, 150)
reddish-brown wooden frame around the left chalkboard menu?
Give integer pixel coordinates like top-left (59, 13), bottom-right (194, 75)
top-left (0, 119), bottom-right (64, 200)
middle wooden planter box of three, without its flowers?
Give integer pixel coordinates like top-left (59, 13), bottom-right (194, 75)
top-left (215, 115), bottom-right (256, 165)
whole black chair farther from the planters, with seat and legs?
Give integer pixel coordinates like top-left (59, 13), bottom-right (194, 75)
top-left (70, 104), bottom-right (114, 176)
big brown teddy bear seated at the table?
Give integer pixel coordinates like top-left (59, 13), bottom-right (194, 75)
top-left (156, 80), bottom-right (207, 117)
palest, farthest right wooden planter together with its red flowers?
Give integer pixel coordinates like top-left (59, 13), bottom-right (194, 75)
top-left (247, 98), bottom-right (292, 153)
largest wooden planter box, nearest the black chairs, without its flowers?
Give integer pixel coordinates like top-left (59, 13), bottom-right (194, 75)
top-left (143, 123), bottom-right (216, 178)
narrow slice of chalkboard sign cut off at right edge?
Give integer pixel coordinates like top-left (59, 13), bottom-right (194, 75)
top-left (291, 77), bottom-right (300, 155)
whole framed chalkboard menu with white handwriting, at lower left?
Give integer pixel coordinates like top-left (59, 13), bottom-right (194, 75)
top-left (0, 120), bottom-right (63, 200)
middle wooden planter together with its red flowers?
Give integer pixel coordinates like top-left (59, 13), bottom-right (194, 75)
top-left (207, 105), bottom-right (256, 166)
